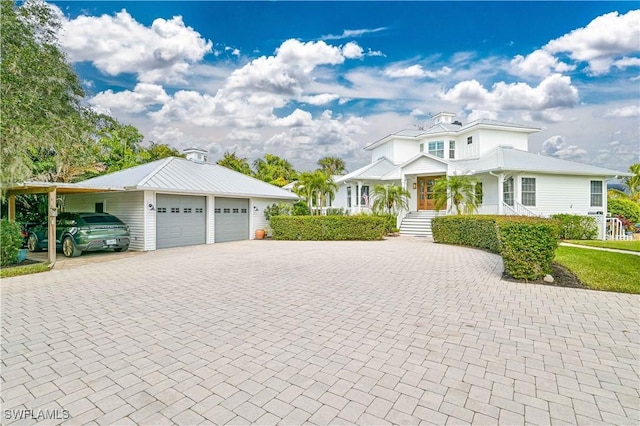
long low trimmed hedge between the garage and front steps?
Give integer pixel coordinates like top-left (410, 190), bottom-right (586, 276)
top-left (270, 215), bottom-right (385, 241)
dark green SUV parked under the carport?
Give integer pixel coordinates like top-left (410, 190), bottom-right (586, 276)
top-left (27, 213), bottom-right (130, 257)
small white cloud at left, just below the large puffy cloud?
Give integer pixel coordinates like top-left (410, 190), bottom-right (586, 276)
top-left (89, 83), bottom-right (171, 112)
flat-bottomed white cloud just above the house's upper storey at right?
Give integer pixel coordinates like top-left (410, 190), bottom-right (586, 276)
top-left (440, 74), bottom-right (578, 111)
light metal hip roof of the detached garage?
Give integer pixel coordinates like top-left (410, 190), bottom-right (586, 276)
top-left (80, 157), bottom-right (298, 200)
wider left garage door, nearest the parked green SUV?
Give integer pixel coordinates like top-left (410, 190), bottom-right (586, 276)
top-left (156, 194), bottom-right (206, 249)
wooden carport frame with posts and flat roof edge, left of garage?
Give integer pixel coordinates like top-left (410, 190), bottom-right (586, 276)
top-left (4, 182), bottom-right (124, 266)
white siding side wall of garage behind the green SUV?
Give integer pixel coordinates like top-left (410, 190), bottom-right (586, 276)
top-left (64, 191), bottom-right (149, 250)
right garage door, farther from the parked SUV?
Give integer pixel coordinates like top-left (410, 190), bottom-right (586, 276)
top-left (214, 197), bottom-right (249, 243)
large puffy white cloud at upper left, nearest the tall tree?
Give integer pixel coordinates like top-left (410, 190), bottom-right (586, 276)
top-left (59, 9), bottom-right (212, 83)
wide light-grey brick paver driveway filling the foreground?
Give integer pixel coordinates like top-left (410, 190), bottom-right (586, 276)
top-left (2, 238), bottom-right (640, 425)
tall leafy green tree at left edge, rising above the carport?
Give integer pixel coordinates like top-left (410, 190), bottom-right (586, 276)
top-left (0, 0), bottom-right (92, 186)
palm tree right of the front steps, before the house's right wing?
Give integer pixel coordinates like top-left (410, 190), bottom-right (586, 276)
top-left (433, 175), bottom-right (478, 214)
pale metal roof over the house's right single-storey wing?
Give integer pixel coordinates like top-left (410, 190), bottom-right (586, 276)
top-left (453, 147), bottom-right (631, 177)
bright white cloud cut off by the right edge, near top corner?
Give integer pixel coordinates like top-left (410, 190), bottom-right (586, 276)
top-left (543, 10), bottom-right (640, 75)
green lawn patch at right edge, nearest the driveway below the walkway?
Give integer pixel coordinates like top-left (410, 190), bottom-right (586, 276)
top-left (555, 246), bottom-right (640, 294)
